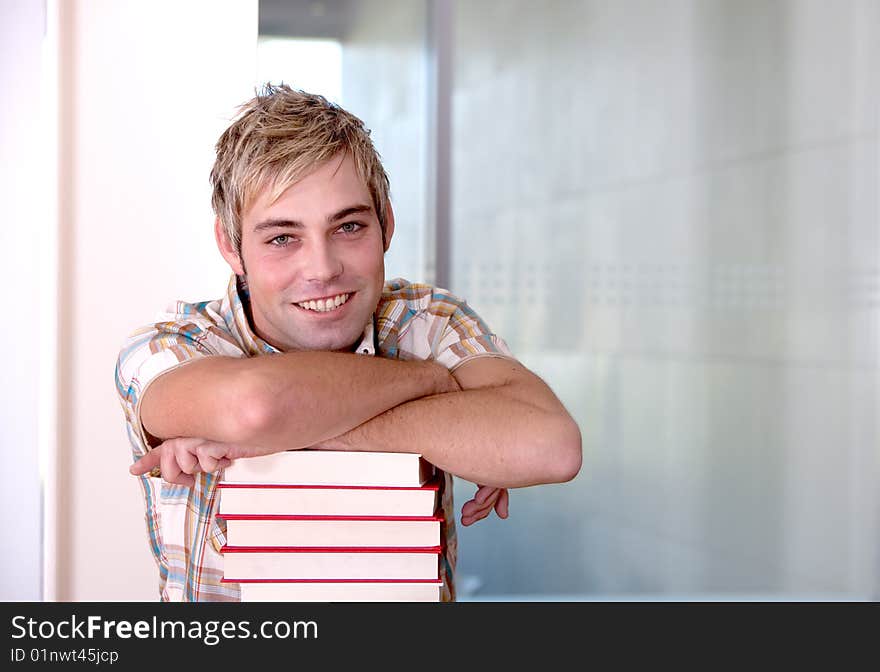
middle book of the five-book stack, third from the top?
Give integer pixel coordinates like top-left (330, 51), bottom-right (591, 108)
top-left (223, 514), bottom-right (441, 548)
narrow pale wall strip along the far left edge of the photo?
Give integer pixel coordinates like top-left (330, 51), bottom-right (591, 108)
top-left (0, 0), bottom-right (51, 600)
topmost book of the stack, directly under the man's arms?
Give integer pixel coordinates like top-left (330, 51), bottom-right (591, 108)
top-left (222, 448), bottom-right (434, 487)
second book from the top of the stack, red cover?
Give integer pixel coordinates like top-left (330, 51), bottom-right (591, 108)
top-left (218, 481), bottom-right (439, 516)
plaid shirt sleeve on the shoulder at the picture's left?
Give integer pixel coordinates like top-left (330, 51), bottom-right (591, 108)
top-left (116, 313), bottom-right (246, 458)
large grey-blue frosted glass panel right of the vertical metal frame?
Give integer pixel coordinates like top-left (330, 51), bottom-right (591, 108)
top-left (452, 0), bottom-right (880, 599)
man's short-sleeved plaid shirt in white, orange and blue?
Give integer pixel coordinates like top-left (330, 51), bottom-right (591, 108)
top-left (116, 276), bottom-right (512, 601)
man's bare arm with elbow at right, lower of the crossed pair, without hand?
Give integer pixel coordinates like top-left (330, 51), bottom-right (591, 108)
top-left (318, 357), bottom-right (582, 488)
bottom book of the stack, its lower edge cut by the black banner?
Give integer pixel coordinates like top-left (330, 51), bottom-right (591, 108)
top-left (230, 579), bottom-right (443, 602)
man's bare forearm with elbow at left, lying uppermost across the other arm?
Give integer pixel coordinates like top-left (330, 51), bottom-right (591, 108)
top-left (140, 352), bottom-right (458, 458)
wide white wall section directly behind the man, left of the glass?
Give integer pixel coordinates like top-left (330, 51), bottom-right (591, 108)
top-left (48, 0), bottom-right (257, 600)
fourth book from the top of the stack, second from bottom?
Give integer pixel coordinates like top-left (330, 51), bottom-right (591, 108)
top-left (222, 545), bottom-right (440, 581)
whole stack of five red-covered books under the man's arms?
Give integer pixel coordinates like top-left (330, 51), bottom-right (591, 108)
top-left (218, 450), bottom-right (442, 602)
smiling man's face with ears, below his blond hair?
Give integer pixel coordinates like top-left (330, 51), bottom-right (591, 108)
top-left (218, 155), bottom-right (393, 352)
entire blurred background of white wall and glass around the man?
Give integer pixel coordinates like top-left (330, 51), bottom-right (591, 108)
top-left (0, 0), bottom-right (880, 601)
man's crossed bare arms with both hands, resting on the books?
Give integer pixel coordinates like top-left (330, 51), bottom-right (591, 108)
top-left (132, 352), bottom-right (581, 524)
